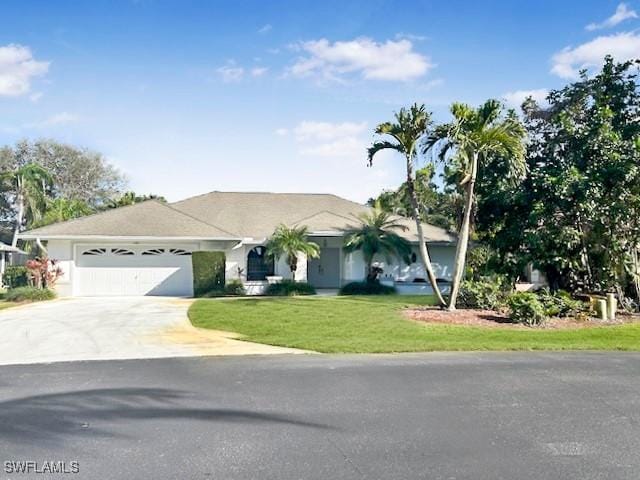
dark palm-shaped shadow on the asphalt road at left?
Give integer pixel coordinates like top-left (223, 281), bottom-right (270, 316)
top-left (0, 388), bottom-right (333, 444)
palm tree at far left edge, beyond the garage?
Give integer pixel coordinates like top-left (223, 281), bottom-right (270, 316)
top-left (2, 163), bottom-right (52, 247)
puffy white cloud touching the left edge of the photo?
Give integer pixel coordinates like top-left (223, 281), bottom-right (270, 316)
top-left (0, 44), bottom-right (49, 97)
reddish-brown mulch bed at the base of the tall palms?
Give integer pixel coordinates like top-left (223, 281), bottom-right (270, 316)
top-left (403, 307), bottom-right (640, 330)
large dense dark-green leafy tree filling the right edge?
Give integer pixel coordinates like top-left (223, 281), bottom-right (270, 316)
top-left (477, 57), bottom-right (640, 299)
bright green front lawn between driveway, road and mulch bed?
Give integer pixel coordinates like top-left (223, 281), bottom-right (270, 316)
top-left (189, 295), bottom-right (640, 353)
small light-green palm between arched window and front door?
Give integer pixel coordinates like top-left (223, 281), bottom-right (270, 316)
top-left (266, 224), bottom-right (320, 280)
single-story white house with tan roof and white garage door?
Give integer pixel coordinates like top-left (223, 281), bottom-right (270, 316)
top-left (20, 192), bottom-right (456, 296)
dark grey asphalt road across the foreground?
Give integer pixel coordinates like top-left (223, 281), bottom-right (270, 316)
top-left (0, 353), bottom-right (640, 480)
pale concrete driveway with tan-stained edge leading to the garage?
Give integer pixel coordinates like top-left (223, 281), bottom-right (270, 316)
top-left (0, 297), bottom-right (308, 365)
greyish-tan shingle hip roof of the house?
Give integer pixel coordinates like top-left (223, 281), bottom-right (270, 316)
top-left (21, 192), bottom-right (455, 242)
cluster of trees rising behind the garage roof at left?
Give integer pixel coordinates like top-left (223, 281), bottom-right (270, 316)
top-left (0, 140), bottom-right (166, 243)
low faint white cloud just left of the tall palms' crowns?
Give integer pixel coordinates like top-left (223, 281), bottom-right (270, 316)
top-left (292, 121), bottom-right (367, 158)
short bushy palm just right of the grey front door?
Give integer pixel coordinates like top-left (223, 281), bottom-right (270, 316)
top-left (344, 205), bottom-right (411, 281)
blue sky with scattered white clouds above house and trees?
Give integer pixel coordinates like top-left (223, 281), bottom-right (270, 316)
top-left (0, 0), bottom-right (640, 201)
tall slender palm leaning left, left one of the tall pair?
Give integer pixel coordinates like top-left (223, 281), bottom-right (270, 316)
top-left (368, 104), bottom-right (446, 305)
